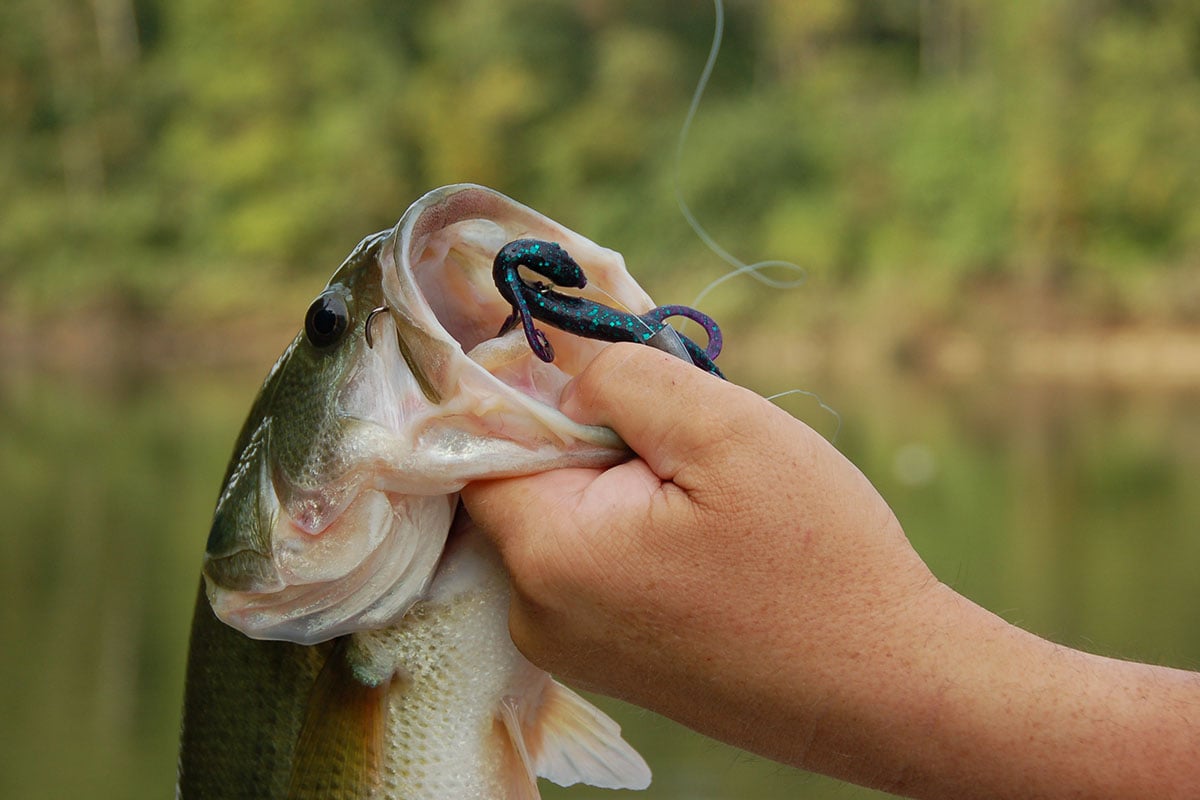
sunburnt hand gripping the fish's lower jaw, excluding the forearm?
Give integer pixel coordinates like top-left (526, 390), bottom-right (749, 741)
top-left (463, 344), bottom-right (937, 763)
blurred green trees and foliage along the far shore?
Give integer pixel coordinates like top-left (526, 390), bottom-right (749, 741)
top-left (7, 0), bottom-right (1200, 318)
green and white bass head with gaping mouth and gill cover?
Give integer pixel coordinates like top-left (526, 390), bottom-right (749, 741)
top-left (204, 185), bottom-right (653, 644)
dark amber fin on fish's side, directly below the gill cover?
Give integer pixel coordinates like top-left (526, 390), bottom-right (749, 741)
top-left (287, 637), bottom-right (389, 800)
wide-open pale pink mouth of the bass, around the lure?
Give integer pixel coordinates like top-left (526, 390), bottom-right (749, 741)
top-left (382, 185), bottom-right (654, 447)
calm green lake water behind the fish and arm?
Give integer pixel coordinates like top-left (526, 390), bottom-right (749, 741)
top-left (0, 363), bottom-right (1200, 800)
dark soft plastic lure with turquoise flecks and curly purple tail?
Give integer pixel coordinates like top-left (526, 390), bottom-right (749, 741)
top-left (492, 239), bottom-right (725, 378)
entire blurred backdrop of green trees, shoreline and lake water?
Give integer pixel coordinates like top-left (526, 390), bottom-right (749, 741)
top-left (0, 0), bottom-right (1200, 799)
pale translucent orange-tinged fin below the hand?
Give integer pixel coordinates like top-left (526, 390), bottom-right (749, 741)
top-left (500, 680), bottom-right (650, 796)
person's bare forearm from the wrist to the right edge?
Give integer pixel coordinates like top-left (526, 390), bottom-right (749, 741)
top-left (775, 585), bottom-right (1200, 800)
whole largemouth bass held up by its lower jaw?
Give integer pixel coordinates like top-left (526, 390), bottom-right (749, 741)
top-left (176, 184), bottom-right (654, 800)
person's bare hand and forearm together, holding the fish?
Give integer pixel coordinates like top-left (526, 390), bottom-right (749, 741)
top-left (463, 344), bottom-right (1200, 800)
